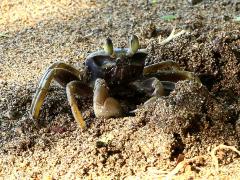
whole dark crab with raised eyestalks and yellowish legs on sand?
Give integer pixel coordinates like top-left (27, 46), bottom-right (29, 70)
top-left (30, 35), bottom-right (201, 129)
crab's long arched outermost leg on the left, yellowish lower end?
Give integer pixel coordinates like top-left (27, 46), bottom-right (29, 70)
top-left (30, 68), bottom-right (82, 119)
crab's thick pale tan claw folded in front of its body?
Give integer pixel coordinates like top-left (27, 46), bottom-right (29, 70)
top-left (93, 78), bottom-right (122, 118)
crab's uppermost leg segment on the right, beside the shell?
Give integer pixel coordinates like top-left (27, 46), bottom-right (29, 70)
top-left (143, 61), bottom-right (180, 75)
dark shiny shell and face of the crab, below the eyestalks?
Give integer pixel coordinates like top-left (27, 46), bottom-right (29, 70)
top-left (86, 48), bottom-right (148, 86)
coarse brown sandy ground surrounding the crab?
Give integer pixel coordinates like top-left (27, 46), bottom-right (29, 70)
top-left (0, 0), bottom-right (240, 179)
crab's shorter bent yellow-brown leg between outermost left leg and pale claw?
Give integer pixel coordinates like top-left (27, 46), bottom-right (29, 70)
top-left (66, 81), bottom-right (91, 129)
